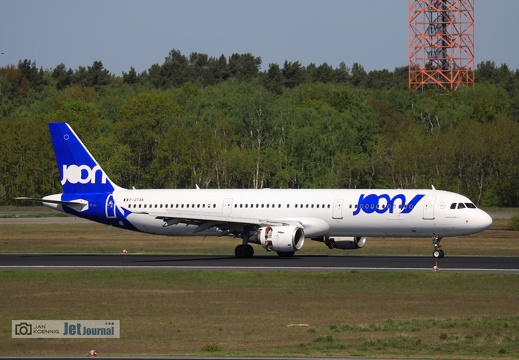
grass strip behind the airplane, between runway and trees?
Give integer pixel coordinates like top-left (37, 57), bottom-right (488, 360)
top-left (0, 223), bottom-right (519, 256)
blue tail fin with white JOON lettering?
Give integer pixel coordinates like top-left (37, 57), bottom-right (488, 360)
top-left (49, 123), bottom-right (120, 194)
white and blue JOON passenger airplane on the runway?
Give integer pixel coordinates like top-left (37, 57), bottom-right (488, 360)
top-left (17, 122), bottom-right (492, 258)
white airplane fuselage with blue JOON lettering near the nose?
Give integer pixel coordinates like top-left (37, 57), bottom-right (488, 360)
top-left (104, 189), bottom-right (492, 237)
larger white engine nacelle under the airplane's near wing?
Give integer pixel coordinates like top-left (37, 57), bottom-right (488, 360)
top-left (258, 226), bottom-right (305, 253)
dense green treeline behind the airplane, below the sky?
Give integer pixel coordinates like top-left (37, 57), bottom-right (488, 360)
top-left (0, 50), bottom-right (519, 206)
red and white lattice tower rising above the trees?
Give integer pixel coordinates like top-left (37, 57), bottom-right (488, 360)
top-left (409, 0), bottom-right (474, 91)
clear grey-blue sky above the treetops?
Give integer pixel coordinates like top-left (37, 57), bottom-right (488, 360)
top-left (0, 0), bottom-right (519, 75)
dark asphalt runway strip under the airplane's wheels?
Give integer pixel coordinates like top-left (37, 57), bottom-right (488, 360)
top-left (0, 254), bottom-right (519, 274)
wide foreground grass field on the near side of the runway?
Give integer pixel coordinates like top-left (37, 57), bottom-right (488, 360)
top-left (0, 270), bottom-right (519, 359)
